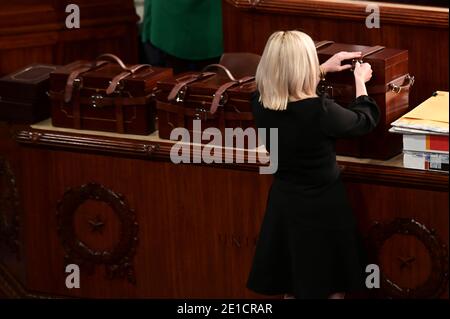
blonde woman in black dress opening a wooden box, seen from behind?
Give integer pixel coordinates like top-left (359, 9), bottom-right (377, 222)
top-left (247, 31), bottom-right (379, 299)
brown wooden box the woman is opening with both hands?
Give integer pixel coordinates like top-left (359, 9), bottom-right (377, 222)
top-left (316, 42), bottom-right (414, 159)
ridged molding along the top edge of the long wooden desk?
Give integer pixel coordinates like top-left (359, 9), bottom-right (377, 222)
top-left (15, 129), bottom-right (449, 192)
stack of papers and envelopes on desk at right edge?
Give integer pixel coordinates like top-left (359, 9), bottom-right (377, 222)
top-left (389, 91), bottom-right (449, 172)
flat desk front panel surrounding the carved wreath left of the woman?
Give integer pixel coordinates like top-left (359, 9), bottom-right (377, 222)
top-left (16, 148), bottom-right (270, 298)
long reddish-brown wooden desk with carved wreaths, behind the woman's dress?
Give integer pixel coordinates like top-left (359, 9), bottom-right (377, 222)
top-left (0, 123), bottom-right (449, 298)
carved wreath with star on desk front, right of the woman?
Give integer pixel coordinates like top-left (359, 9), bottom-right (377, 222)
top-left (369, 218), bottom-right (448, 299)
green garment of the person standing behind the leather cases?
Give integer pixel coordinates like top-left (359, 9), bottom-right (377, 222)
top-left (141, 0), bottom-right (223, 60)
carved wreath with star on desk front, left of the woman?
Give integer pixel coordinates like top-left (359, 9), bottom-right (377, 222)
top-left (57, 183), bottom-right (138, 283)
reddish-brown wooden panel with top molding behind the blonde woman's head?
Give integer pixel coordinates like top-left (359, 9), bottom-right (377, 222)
top-left (223, 0), bottom-right (448, 106)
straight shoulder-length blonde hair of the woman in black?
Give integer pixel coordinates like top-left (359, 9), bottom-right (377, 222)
top-left (256, 31), bottom-right (320, 110)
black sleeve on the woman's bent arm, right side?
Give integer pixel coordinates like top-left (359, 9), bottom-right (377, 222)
top-left (320, 95), bottom-right (380, 138)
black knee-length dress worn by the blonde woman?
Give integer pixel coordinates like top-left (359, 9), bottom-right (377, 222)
top-left (247, 93), bottom-right (379, 299)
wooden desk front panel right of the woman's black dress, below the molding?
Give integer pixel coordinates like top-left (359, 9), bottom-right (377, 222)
top-left (345, 179), bottom-right (449, 298)
